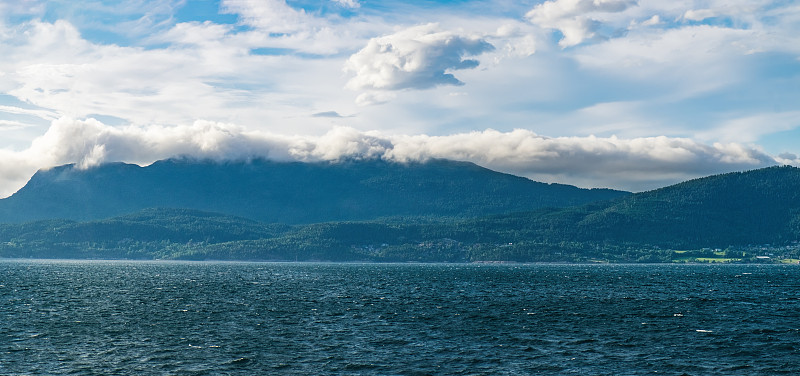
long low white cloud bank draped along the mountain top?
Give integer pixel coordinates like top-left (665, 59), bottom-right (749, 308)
top-left (0, 118), bottom-right (788, 197)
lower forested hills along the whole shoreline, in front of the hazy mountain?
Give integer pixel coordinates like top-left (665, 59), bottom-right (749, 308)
top-left (0, 167), bottom-right (800, 262)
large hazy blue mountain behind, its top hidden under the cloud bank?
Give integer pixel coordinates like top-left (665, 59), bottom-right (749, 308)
top-left (0, 159), bottom-right (628, 224)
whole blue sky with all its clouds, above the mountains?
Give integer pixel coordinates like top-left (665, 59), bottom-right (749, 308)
top-left (0, 0), bottom-right (800, 197)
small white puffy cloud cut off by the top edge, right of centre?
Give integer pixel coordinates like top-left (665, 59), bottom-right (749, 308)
top-left (525, 0), bottom-right (637, 47)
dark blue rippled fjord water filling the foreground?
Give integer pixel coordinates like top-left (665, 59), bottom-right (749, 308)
top-left (0, 261), bottom-right (800, 375)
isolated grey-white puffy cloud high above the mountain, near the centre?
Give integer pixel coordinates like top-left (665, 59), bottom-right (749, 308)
top-left (345, 24), bottom-right (494, 90)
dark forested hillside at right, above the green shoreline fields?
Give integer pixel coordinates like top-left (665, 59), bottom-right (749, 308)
top-left (493, 167), bottom-right (800, 249)
